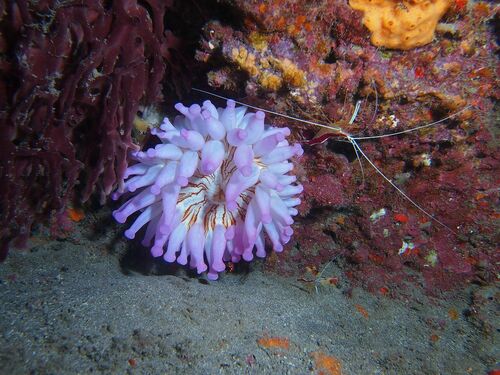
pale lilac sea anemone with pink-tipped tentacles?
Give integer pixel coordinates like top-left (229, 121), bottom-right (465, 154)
top-left (113, 100), bottom-right (303, 280)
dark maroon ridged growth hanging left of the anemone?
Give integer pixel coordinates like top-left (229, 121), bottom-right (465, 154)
top-left (0, 0), bottom-right (177, 258)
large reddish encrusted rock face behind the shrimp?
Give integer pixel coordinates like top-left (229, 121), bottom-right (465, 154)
top-left (196, 0), bottom-right (500, 294)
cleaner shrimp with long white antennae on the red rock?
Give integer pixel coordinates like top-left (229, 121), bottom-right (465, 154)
top-left (192, 88), bottom-right (472, 235)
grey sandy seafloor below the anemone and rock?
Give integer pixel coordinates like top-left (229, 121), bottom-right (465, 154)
top-left (0, 210), bottom-right (500, 375)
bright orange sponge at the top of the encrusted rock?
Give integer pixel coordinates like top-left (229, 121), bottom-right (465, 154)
top-left (349, 0), bottom-right (451, 50)
